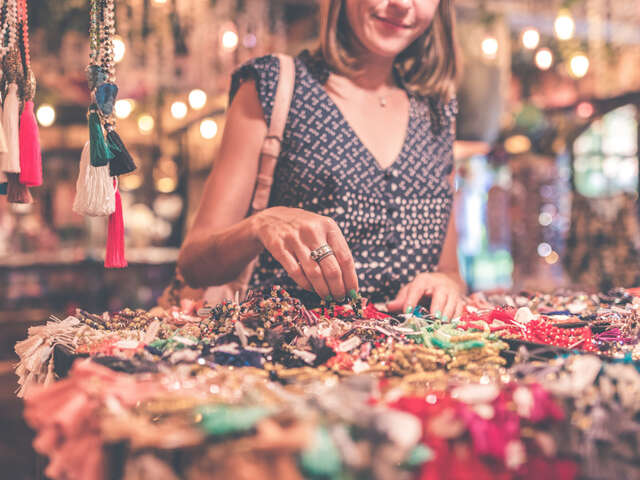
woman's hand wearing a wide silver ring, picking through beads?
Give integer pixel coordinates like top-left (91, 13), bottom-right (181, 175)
top-left (252, 207), bottom-right (358, 300)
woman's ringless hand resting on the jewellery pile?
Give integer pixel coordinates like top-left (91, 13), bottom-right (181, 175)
top-left (387, 272), bottom-right (466, 321)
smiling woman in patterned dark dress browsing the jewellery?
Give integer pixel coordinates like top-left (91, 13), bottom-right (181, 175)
top-left (178, 0), bottom-right (465, 319)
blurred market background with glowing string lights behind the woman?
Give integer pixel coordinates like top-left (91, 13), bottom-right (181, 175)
top-left (0, 0), bottom-right (640, 479)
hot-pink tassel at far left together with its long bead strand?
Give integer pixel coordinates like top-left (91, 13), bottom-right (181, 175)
top-left (18, 0), bottom-right (42, 187)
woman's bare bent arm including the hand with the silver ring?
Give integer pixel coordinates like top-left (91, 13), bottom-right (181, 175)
top-left (178, 78), bottom-right (358, 299)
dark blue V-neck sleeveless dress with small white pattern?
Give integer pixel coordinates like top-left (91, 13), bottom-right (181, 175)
top-left (230, 51), bottom-right (457, 303)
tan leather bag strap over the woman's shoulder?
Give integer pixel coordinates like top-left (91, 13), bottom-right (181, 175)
top-left (251, 54), bottom-right (296, 213)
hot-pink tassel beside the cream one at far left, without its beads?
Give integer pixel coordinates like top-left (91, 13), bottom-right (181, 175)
top-left (20, 100), bottom-right (42, 187)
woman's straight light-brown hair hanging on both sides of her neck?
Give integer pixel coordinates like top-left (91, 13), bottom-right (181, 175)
top-left (316, 0), bottom-right (460, 101)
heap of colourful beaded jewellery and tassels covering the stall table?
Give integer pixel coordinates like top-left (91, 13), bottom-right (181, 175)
top-left (16, 288), bottom-right (640, 479)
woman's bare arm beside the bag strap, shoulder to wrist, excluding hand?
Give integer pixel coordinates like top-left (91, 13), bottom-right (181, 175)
top-left (178, 81), bottom-right (267, 286)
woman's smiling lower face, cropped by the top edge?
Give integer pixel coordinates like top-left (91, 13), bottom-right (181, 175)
top-left (345, 0), bottom-right (440, 58)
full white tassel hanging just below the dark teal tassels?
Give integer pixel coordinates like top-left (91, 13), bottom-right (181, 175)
top-left (73, 142), bottom-right (116, 217)
